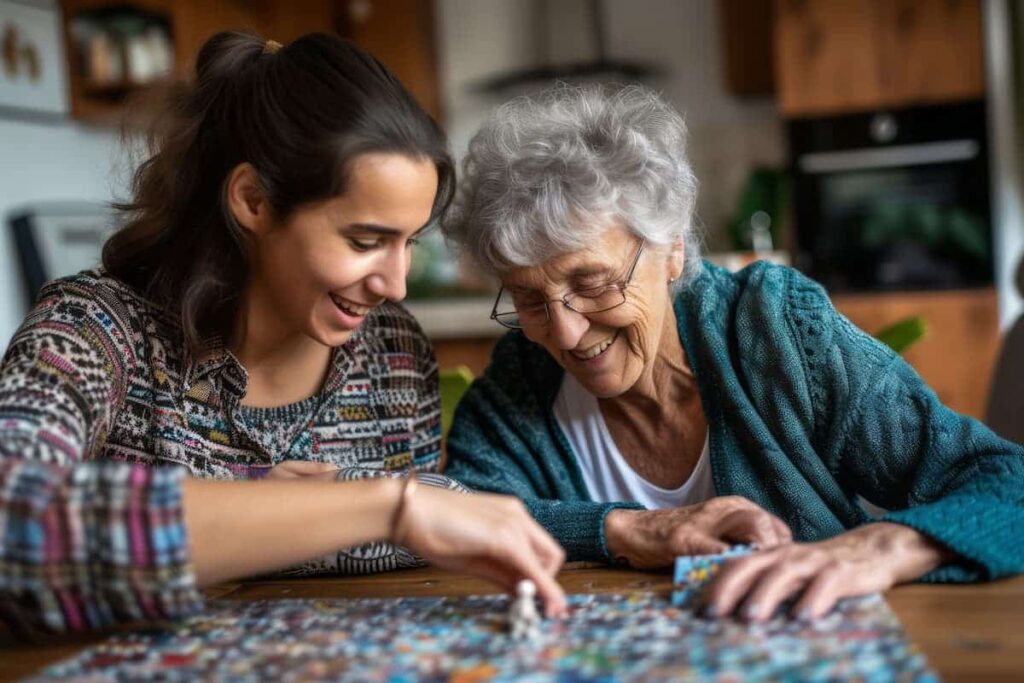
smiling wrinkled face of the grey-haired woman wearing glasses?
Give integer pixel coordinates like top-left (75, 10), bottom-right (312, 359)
top-left (501, 227), bottom-right (683, 398)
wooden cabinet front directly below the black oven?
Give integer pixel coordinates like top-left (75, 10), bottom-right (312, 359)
top-left (833, 289), bottom-right (999, 419)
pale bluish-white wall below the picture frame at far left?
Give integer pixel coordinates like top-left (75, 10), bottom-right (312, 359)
top-left (0, 119), bottom-right (124, 350)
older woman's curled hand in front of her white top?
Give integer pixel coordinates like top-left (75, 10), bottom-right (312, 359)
top-left (604, 496), bottom-right (793, 569)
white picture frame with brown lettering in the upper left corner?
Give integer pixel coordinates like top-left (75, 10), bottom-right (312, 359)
top-left (0, 0), bottom-right (70, 119)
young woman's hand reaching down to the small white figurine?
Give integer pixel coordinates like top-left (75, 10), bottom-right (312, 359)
top-left (392, 482), bottom-right (566, 616)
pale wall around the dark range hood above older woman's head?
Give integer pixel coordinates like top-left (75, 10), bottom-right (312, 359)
top-left (437, 0), bottom-right (785, 248)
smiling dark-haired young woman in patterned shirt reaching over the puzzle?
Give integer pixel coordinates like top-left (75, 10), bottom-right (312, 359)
top-left (0, 34), bottom-right (564, 630)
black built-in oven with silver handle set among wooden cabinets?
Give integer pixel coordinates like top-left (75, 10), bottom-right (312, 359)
top-left (788, 100), bottom-right (992, 292)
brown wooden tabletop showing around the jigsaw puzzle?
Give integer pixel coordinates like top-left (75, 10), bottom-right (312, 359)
top-left (0, 564), bottom-right (1024, 682)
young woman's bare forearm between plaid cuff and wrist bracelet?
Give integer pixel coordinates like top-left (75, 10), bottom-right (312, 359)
top-left (182, 479), bottom-right (402, 586)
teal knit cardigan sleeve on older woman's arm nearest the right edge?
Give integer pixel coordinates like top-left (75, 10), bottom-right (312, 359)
top-left (805, 276), bottom-right (1024, 582)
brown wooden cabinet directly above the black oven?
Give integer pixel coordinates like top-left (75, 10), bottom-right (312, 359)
top-left (775, 0), bottom-right (985, 117)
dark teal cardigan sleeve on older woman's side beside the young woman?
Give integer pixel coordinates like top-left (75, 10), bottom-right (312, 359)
top-left (445, 350), bottom-right (642, 562)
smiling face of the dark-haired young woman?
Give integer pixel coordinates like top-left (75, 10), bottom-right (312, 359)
top-left (252, 154), bottom-right (437, 346)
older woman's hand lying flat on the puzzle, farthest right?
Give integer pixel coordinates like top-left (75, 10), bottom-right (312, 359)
top-left (705, 522), bottom-right (952, 622)
